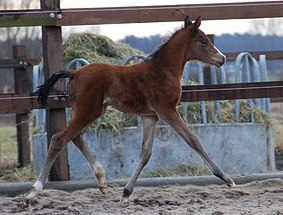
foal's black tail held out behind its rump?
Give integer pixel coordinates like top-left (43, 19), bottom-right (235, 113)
top-left (35, 70), bottom-right (72, 106)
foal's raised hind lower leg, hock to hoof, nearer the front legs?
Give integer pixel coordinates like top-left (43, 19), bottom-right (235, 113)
top-left (73, 134), bottom-right (107, 194)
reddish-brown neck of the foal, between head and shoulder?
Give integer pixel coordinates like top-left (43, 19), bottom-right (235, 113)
top-left (153, 30), bottom-right (191, 80)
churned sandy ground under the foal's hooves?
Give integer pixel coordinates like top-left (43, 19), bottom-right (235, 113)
top-left (0, 179), bottom-right (283, 215)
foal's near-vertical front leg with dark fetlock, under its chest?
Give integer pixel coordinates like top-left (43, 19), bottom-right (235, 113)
top-left (121, 116), bottom-right (158, 203)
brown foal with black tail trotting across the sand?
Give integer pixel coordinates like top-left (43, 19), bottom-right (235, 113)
top-left (23, 17), bottom-right (235, 207)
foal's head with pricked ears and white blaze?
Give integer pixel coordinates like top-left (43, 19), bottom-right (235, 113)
top-left (185, 16), bottom-right (226, 67)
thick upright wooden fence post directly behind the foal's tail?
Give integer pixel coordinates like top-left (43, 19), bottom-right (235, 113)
top-left (40, 0), bottom-right (69, 181)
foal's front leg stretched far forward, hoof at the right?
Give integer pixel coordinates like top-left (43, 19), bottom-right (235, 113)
top-left (159, 109), bottom-right (235, 187)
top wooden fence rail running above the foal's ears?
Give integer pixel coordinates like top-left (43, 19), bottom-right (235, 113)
top-left (0, 1), bottom-right (283, 27)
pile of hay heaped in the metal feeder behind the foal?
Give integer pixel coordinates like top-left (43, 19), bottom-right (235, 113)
top-left (63, 33), bottom-right (272, 130)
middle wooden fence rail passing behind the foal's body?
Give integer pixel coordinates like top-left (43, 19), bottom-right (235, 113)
top-left (0, 81), bottom-right (283, 114)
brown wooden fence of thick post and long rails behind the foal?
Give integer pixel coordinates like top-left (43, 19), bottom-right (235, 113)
top-left (0, 0), bottom-right (283, 180)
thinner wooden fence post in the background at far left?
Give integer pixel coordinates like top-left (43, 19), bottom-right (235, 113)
top-left (13, 46), bottom-right (33, 167)
